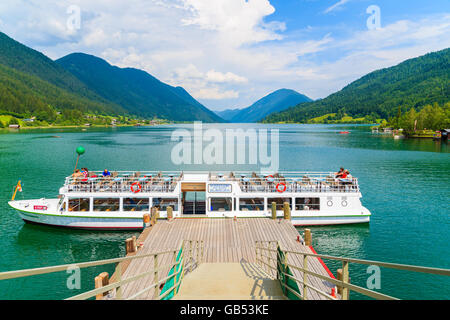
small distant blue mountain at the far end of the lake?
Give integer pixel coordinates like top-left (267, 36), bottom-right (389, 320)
top-left (221, 89), bottom-right (312, 123)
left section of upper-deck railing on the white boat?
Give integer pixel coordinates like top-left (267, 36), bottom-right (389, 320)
top-left (64, 171), bottom-right (183, 193)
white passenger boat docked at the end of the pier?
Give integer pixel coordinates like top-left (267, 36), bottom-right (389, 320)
top-left (9, 172), bottom-right (371, 230)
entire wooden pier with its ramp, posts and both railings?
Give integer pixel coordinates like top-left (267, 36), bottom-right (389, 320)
top-left (0, 215), bottom-right (450, 300)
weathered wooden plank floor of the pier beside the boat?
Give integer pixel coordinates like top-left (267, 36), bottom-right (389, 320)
top-left (108, 218), bottom-right (340, 300)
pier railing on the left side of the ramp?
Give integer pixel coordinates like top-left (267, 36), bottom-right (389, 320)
top-left (0, 240), bottom-right (204, 300)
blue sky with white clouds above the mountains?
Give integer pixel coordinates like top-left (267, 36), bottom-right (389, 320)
top-left (0, 0), bottom-right (450, 111)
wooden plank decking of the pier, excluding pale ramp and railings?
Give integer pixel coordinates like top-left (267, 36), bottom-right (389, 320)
top-left (111, 218), bottom-right (339, 300)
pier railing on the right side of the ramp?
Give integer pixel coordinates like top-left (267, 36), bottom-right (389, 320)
top-left (256, 241), bottom-right (450, 300)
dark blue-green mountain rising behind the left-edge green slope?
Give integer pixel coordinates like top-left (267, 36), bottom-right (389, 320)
top-left (56, 53), bottom-right (223, 122)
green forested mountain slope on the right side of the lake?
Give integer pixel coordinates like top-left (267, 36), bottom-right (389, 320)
top-left (264, 49), bottom-right (450, 122)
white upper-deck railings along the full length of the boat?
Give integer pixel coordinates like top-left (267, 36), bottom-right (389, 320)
top-left (63, 171), bottom-right (360, 193)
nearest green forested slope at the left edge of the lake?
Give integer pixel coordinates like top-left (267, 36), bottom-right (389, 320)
top-left (0, 32), bottom-right (125, 114)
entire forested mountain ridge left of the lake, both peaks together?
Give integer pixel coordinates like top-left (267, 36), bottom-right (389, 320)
top-left (0, 32), bottom-right (223, 125)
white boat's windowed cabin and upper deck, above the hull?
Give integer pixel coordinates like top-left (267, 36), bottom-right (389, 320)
top-left (60, 172), bottom-right (360, 217)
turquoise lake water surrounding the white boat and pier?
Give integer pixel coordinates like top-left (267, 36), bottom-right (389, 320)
top-left (0, 125), bottom-right (450, 299)
